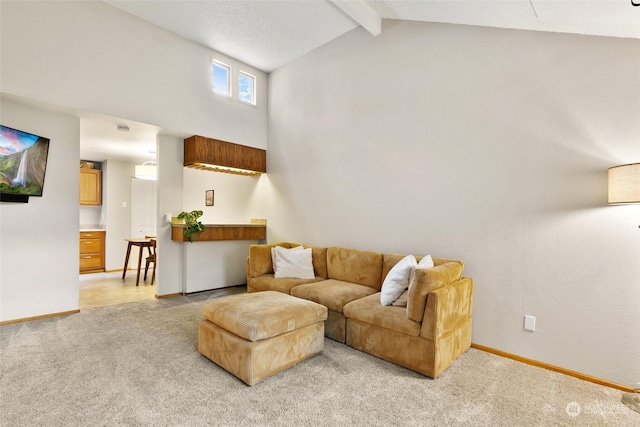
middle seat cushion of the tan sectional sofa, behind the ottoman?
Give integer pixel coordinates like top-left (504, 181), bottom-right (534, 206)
top-left (291, 279), bottom-right (376, 313)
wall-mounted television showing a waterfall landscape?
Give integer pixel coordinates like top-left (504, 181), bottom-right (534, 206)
top-left (0, 125), bottom-right (49, 202)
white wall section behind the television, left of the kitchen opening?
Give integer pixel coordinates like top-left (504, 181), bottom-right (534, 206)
top-left (0, 99), bottom-right (80, 321)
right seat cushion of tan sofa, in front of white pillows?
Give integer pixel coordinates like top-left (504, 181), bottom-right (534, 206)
top-left (343, 294), bottom-right (420, 337)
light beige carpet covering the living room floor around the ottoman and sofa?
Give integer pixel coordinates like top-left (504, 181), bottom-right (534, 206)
top-left (0, 292), bottom-right (640, 427)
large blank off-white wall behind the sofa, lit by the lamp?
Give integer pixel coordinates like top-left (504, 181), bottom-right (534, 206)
top-left (268, 22), bottom-right (640, 385)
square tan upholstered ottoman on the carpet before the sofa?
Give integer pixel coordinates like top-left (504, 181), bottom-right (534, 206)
top-left (198, 291), bottom-right (327, 385)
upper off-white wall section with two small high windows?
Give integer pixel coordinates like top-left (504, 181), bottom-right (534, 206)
top-left (0, 1), bottom-right (267, 148)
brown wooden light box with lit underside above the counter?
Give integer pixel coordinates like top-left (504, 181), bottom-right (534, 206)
top-left (184, 135), bottom-right (267, 175)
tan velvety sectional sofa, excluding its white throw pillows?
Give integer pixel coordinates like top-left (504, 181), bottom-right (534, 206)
top-left (247, 242), bottom-right (473, 378)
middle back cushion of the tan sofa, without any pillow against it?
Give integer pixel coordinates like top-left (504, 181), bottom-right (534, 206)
top-left (327, 247), bottom-right (382, 291)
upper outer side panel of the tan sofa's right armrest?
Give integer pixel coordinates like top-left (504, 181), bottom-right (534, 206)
top-left (420, 277), bottom-right (473, 341)
